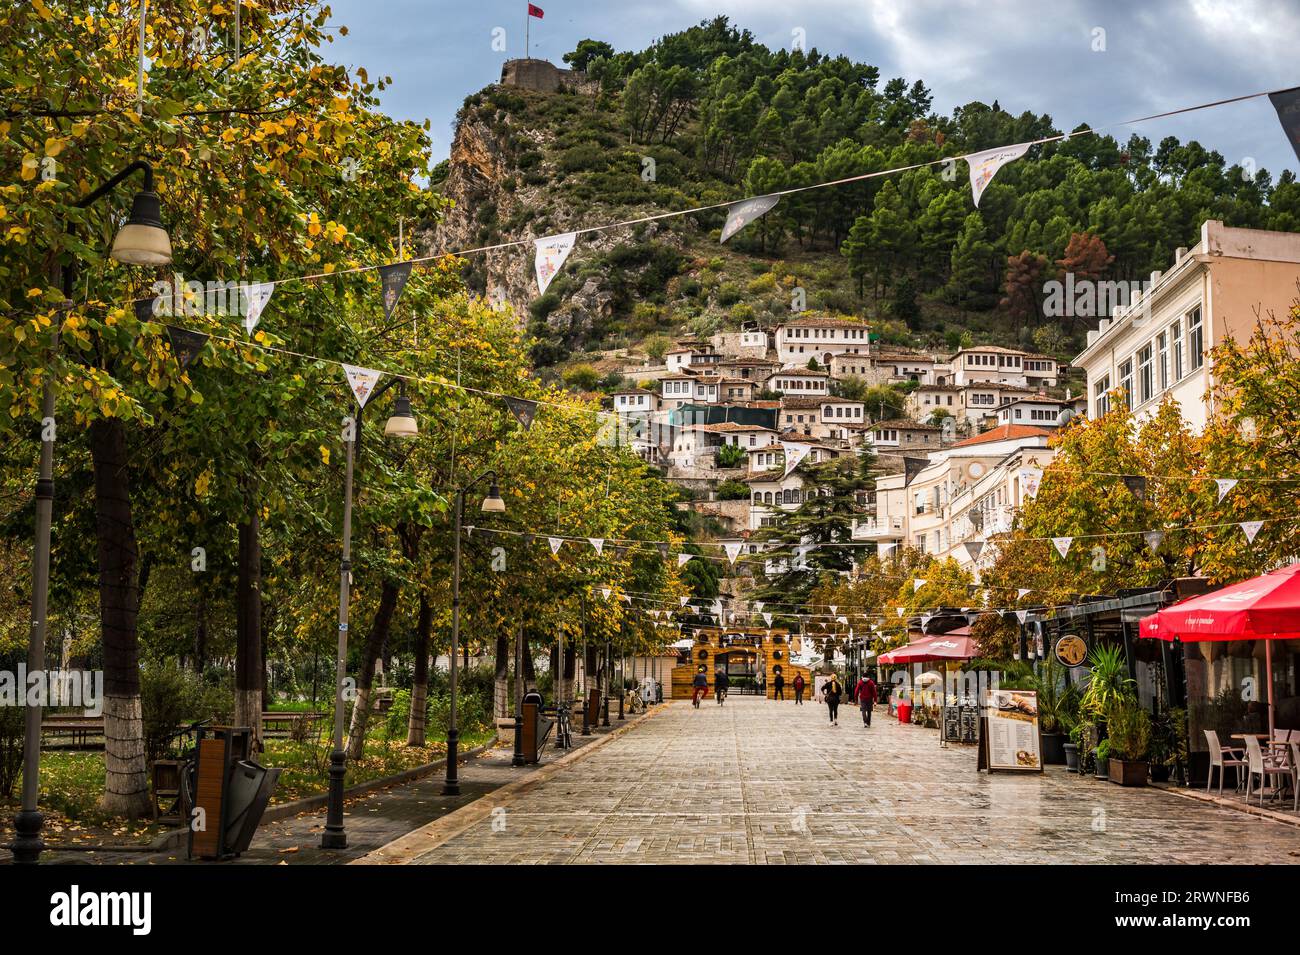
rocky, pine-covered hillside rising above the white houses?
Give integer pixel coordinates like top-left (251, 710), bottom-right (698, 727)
top-left (426, 18), bottom-right (1300, 382)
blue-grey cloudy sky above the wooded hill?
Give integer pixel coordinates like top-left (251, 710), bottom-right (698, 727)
top-left (329, 0), bottom-right (1300, 179)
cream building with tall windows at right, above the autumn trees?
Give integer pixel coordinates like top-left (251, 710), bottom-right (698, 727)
top-left (1074, 220), bottom-right (1300, 430)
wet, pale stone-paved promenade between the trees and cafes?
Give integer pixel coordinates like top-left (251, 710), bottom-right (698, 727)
top-left (415, 696), bottom-right (1300, 864)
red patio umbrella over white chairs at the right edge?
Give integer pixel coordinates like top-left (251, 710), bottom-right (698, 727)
top-left (1138, 563), bottom-right (1300, 738)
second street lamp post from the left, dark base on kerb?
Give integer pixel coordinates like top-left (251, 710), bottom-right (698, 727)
top-left (321, 378), bottom-right (419, 848)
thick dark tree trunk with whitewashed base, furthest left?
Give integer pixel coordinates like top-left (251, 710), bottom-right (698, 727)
top-left (90, 418), bottom-right (150, 817)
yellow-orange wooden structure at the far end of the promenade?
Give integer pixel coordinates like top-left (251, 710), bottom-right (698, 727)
top-left (672, 626), bottom-right (813, 699)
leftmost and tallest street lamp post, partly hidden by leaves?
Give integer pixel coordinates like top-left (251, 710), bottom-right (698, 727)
top-left (12, 162), bottom-right (172, 864)
